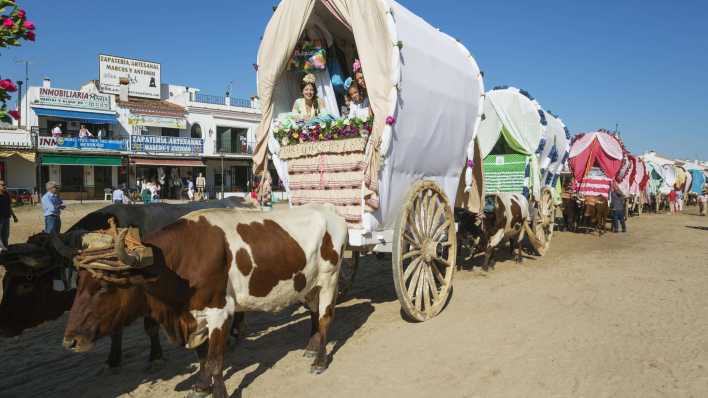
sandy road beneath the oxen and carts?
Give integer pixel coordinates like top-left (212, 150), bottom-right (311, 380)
top-left (0, 204), bottom-right (708, 398)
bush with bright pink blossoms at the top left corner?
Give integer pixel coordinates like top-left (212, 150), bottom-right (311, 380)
top-left (0, 0), bottom-right (36, 123)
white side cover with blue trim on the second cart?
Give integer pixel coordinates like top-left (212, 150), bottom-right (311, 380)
top-left (538, 111), bottom-right (570, 186)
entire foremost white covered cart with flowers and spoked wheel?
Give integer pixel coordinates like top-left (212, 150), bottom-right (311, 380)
top-left (254, 0), bottom-right (484, 321)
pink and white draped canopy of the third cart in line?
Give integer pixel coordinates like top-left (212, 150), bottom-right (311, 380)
top-left (569, 131), bottom-right (624, 180)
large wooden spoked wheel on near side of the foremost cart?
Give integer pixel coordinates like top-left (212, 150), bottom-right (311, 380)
top-left (392, 181), bottom-right (457, 322)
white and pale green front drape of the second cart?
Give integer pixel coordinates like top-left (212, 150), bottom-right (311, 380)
top-left (477, 87), bottom-right (544, 197)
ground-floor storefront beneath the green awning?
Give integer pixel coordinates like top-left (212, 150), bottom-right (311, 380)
top-left (40, 153), bottom-right (127, 200)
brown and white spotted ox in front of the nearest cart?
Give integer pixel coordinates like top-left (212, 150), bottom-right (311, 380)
top-left (64, 205), bottom-right (347, 398)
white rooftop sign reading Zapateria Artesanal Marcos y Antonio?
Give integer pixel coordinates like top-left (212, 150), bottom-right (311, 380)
top-left (98, 55), bottom-right (160, 99)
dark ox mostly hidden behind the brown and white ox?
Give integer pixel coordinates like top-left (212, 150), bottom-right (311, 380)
top-left (0, 199), bottom-right (243, 367)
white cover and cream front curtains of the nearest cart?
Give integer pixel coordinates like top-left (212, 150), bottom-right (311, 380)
top-left (253, 0), bottom-right (484, 230)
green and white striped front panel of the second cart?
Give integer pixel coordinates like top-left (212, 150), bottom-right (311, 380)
top-left (484, 154), bottom-right (531, 193)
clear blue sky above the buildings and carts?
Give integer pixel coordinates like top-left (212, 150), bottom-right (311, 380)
top-left (0, 0), bottom-right (708, 160)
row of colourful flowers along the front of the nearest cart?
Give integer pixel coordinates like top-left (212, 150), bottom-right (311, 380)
top-left (273, 118), bottom-right (373, 146)
